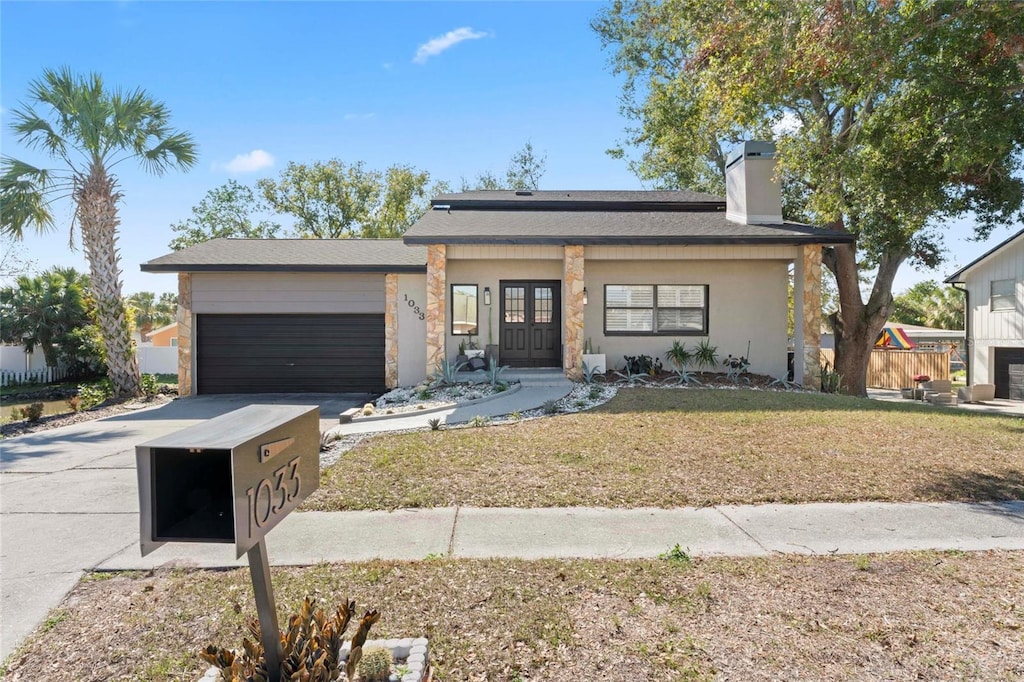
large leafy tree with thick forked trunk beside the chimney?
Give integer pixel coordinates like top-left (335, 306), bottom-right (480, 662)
top-left (594, 0), bottom-right (1024, 394)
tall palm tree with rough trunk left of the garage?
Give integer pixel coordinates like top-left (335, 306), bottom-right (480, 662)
top-left (0, 68), bottom-right (196, 399)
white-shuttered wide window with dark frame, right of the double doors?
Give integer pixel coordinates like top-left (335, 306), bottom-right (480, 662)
top-left (604, 285), bottom-right (708, 336)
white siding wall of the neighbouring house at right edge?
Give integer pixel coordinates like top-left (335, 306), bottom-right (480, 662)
top-left (965, 238), bottom-right (1024, 383)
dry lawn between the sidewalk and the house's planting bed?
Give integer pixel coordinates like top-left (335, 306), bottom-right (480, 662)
top-left (305, 389), bottom-right (1024, 510)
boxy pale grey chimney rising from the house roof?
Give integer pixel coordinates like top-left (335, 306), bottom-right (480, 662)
top-left (725, 142), bottom-right (782, 225)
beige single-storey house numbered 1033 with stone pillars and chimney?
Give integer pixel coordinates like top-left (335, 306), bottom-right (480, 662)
top-left (142, 142), bottom-right (852, 393)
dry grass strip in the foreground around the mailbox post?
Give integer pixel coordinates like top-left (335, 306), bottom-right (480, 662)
top-left (4, 552), bottom-right (1024, 682)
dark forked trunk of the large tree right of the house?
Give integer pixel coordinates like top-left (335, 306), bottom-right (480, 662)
top-left (822, 244), bottom-right (907, 396)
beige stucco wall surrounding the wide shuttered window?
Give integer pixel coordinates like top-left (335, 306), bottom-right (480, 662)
top-left (584, 258), bottom-right (788, 377)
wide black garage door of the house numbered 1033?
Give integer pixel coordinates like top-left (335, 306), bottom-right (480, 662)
top-left (196, 314), bottom-right (384, 393)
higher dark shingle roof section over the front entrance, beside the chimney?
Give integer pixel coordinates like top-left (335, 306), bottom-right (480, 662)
top-left (404, 207), bottom-right (853, 245)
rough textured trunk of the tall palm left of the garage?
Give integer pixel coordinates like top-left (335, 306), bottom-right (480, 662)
top-left (74, 163), bottom-right (141, 400)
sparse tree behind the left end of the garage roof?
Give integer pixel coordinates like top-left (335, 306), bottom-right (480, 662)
top-left (168, 180), bottom-right (281, 251)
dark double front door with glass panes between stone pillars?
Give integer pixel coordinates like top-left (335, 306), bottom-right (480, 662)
top-left (498, 280), bottom-right (562, 367)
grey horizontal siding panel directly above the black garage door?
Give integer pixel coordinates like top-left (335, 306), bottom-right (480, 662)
top-left (191, 272), bottom-right (384, 314)
